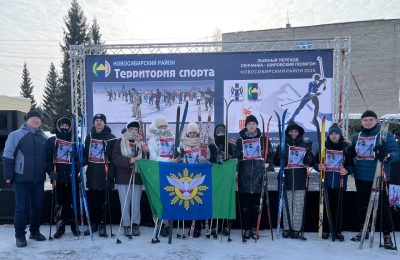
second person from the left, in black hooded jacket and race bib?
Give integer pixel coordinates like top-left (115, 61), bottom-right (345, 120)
top-left (47, 116), bottom-right (79, 239)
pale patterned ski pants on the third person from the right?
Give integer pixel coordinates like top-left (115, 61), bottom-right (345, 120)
top-left (282, 190), bottom-right (306, 231)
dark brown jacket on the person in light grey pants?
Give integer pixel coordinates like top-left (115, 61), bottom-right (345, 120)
top-left (112, 138), bottom-right (143, 185)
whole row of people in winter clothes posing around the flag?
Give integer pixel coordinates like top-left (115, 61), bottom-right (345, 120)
top-left (3, 110), bottom-right (399, 248)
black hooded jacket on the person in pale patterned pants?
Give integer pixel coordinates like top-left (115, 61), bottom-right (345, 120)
top-left (274, 122), bottom-right (314, 190)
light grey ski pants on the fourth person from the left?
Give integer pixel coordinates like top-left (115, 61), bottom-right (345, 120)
top-left (115, 184), bottom-right (143, 227)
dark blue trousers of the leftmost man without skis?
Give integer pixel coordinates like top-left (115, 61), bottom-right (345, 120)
top-left (14, 182), bottom-right (44, 238)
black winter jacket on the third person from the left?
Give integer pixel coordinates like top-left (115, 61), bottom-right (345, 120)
top-left (84, 126), bottom-right (116, 190)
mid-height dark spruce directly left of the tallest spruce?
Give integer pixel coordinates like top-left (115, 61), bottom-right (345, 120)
top-left (42, 63), bottom-right (59, 130)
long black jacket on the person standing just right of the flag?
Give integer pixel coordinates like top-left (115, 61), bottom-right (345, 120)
top-left (234, 128), bottom-right (272, 193)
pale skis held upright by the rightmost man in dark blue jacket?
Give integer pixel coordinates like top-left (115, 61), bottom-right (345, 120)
top-left (359, 121), bottom-right (389, 249)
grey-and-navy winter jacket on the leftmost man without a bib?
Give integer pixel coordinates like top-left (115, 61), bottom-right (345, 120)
top-left (3, 124), bottom-right (47, 183)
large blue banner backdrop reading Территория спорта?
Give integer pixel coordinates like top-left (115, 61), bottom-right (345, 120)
top-left (85, 50), bottom-right (333, 140)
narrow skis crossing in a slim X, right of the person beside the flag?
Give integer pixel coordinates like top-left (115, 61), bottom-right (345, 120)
top-left (255, 114), bottom-right (274, 242)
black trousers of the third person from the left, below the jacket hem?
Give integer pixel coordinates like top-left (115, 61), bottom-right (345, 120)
top-left (89, 190), bottom-right (110, 225)
